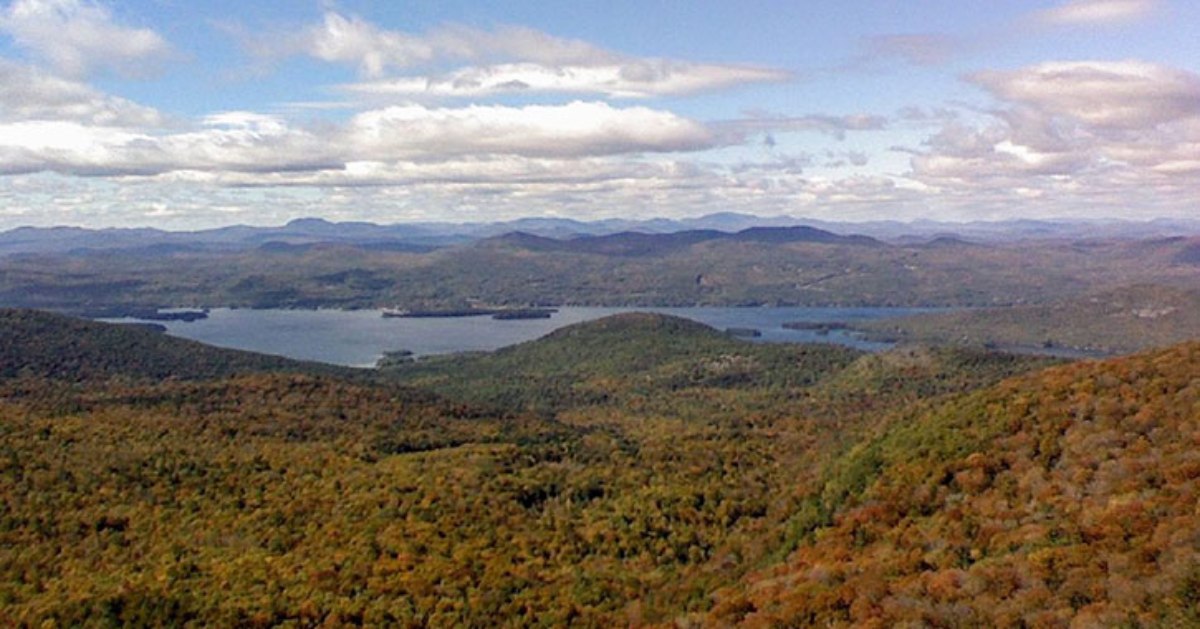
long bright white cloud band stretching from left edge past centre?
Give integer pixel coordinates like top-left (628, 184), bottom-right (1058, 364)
top-left (0, 102), bottom-right (716, 175)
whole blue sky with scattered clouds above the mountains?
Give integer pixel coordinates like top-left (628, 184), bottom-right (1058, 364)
top-left (0, 0), bottom-right (1200, 229)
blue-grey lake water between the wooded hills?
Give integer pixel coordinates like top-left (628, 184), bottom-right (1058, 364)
top-left (110, 307), bottom-right (928, 366)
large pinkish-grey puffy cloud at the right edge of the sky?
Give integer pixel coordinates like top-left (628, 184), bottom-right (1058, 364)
top-left (914, 61), bottom-right (1200, 181)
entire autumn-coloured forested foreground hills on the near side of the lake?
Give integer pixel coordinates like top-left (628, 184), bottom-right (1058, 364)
top-left (0, 306), bottom-right (1200, 627)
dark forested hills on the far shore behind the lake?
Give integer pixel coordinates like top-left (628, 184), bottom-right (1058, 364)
top-left (0, 227), bottom-right (1200, 308)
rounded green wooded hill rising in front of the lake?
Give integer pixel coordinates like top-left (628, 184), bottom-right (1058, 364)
top-left (388, 312), bottom-right (860, 411)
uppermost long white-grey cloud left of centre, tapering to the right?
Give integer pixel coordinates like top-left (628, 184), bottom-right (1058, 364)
top-left (240, 11), bottom-right (791, 98)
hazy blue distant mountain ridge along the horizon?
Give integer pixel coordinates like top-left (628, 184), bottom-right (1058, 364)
top-left (0, 212), bottom-right (1200, 256)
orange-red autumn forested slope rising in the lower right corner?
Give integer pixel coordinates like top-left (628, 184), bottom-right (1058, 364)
top-left (708, 343), bottom-right (1200, 627)
